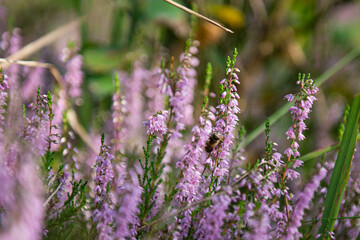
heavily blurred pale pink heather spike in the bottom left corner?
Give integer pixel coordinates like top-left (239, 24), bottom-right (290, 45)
top-left (0, 149), bottom-right (44, 240)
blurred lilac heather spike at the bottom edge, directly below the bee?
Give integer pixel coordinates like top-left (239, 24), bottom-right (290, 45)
top-left (194, 195), bottom-right (231, 240)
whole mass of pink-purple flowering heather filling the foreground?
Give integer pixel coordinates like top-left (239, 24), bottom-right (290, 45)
top-left (0, 22), bottom-right (360, 239)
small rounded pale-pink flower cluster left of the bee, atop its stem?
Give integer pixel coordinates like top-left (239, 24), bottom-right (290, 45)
top-left (144, 110), bottom-right (168, 144)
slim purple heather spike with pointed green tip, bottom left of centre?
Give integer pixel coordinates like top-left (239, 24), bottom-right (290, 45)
top-left (92, 142), bottom-right (114, 239)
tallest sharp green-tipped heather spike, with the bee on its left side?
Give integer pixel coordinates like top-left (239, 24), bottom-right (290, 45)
top-left (212, 54), bottom-right (240, 181)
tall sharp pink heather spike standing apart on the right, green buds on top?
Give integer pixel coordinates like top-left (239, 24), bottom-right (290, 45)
top-left (284, 75), bottom-right (319, 165)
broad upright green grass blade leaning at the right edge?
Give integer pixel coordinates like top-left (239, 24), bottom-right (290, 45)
top-left (319, 93), bottom-right (360, 239)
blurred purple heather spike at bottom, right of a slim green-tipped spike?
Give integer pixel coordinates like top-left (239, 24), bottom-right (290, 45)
top-left (115, 172), bottom-right (142, 239)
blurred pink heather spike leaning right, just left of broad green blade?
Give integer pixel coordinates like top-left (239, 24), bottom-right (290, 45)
top-left (284, 167), bottom-right (327, 239)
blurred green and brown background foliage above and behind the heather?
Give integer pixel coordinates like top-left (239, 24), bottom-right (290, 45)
top-left (0, 0), bottom-right (360, 172)
